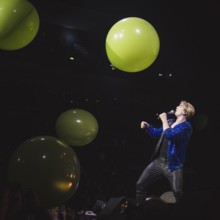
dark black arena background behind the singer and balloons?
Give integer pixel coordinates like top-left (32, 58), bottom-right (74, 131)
top-left (0, 0), bottom-right (220, 210)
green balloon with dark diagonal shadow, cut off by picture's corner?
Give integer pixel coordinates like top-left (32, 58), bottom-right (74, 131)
top-left (0, 0), bottom-right (40, 50)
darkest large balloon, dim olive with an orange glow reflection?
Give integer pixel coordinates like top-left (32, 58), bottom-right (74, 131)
top-left (8, 136), bottom-right (80, 207)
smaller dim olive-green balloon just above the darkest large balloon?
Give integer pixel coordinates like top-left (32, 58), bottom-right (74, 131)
top-left (56, 109), bottom-right (98, 146)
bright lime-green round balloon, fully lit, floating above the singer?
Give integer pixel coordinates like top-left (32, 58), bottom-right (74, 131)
top-left (106, 17), bottom-right (160, 72)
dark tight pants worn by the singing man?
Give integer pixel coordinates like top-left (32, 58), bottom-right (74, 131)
top-left (136, 158), bottom-right (183, 205)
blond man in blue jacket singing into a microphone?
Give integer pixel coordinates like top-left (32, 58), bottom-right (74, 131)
top-left (136, 100), bottom-right (195, 205)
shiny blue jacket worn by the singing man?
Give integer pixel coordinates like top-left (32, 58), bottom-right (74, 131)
top-left (146, 119), bottom-right (192, 171)
